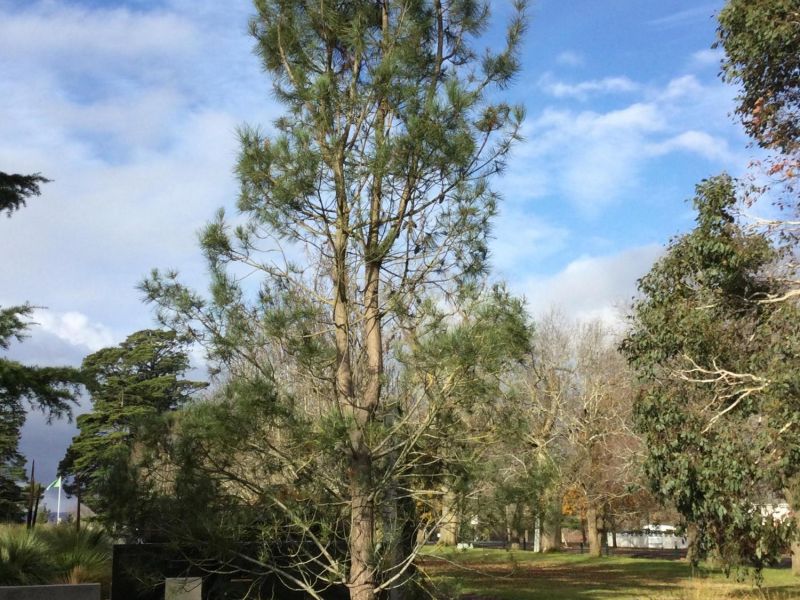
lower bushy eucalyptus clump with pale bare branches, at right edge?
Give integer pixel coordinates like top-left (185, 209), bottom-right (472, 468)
top-left (623, 176), bottom-right (800, 567)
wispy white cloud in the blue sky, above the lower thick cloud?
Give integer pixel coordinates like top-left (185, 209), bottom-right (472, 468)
top-left (501, 75), bottom-right (749, 216)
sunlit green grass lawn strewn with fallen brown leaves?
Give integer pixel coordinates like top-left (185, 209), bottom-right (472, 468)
top-left (420, 549), bottom-right (800, 600)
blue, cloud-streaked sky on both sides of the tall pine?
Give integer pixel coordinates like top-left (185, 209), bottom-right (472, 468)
top-left (0, 0), bottom-right (753, 507)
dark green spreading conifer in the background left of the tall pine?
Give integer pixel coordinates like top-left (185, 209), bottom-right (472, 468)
top-left (59, 330), bottom-right (205, 534)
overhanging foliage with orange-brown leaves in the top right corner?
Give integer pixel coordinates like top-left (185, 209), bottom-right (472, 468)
top-left (717, 0), bottom-right (800, 302)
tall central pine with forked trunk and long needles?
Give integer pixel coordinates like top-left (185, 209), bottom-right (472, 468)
top-left (144, 0), bottom-right (525, 600)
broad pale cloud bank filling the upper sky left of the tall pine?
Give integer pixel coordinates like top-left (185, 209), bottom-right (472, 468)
top-left (0, 0), bottom-right (275, 331)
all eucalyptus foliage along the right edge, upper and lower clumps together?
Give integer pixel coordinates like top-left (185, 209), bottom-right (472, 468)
top-left (624, 0), bottom-right (800, 572)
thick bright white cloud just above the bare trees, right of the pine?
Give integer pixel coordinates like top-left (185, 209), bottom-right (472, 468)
top-left (518, 244), bottom-right (663, 325)
